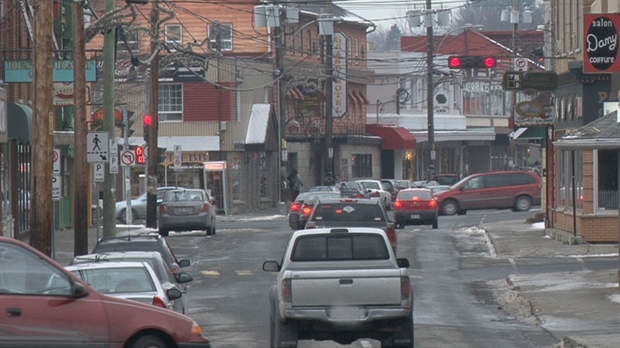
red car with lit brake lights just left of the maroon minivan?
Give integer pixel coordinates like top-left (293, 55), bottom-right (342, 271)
top-left (394, 188), bottom-right (439, 229)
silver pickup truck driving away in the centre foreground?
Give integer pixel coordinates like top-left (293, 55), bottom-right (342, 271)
top-left (263, 227), bottom-right (413, 348)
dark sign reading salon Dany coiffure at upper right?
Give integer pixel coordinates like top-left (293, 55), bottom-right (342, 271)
top-left (583, 13), bottom-right (620, 73)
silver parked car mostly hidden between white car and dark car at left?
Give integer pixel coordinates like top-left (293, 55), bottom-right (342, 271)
top-left (69, 251), bottom-right (193, 314)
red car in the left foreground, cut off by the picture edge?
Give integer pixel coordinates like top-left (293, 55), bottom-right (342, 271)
top-left (0, 237), bottom-right (211, 348)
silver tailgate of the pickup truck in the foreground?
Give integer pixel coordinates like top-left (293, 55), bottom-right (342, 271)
top-left (291, 269), bottom-right (401, 307)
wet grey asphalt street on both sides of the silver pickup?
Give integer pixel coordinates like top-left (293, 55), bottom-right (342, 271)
top-left (167, 211), bottom-right (617, 348)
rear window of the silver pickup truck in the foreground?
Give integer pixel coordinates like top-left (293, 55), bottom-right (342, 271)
top-left (291, 233), bottom-right (390, 261)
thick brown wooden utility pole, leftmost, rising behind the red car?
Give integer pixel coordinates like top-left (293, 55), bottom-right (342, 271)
top-left (30, 1), bottom-right (54, 256)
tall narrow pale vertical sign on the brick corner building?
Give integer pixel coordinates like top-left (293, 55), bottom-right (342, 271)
top-left (332, 33), bottom-right (347, 117)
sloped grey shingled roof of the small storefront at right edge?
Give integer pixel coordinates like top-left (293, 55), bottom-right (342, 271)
top-left (553, 111), bottom-right (620, 150)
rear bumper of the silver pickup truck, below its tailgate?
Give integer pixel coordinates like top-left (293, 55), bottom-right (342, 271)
top-left (284, 307), bottom-right (411, 324)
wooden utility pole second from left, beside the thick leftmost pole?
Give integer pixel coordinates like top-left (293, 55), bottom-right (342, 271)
top-left (73, 2), bottom-right (88, 256)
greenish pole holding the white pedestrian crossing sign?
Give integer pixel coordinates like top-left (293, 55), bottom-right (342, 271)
top-left (102, 0), bottom-right (116, 237)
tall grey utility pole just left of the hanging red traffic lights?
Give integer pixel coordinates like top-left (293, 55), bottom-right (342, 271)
top-left (424, 0), bottom-right (436, 180)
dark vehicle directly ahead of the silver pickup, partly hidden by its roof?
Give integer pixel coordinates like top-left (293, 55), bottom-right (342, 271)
top-left (305, 198), bottom-right (397, 252)
